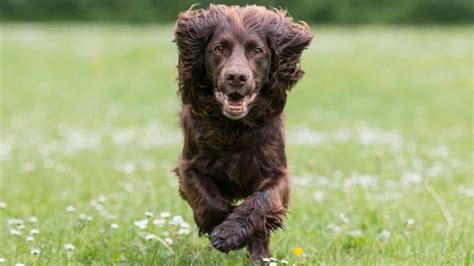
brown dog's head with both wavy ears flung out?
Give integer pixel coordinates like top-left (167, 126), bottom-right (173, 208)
top-left (175, 5), bottom-right (313, 120)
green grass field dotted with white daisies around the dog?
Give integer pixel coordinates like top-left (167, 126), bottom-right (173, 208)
top-left (0, 24), bottom-right (474, 265)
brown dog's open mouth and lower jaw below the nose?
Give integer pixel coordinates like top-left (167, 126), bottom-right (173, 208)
top-left (215, 91), bottom-right (257, 120)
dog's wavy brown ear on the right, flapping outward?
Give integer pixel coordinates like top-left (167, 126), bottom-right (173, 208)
top-left (271, 10), bottom-right (313, 90)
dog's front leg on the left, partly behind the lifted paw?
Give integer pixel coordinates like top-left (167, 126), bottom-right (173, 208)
top-left (179, 170), bottom-right (233, 234)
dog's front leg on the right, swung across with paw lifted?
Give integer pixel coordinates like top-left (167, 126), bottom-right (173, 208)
top-left (210, 174), bottom-right (289, 259)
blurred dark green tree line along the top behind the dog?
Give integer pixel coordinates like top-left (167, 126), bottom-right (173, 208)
top-left (0, 0), bottom-right (474, 23)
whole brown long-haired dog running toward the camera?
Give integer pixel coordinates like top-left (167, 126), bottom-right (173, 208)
top-left (175, 5), bottom-right (313, 260)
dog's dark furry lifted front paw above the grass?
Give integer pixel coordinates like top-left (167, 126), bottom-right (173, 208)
top-left (209, 220), bottom-right (252, 253)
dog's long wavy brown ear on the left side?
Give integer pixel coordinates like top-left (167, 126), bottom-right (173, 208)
top-left (174, 5), bottom-right (218, 103)
